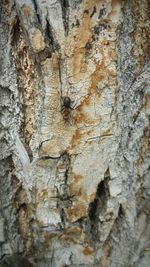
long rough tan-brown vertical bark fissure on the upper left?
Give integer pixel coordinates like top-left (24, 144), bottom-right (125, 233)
top-left (12, 24), bottom-right (36, 160)
